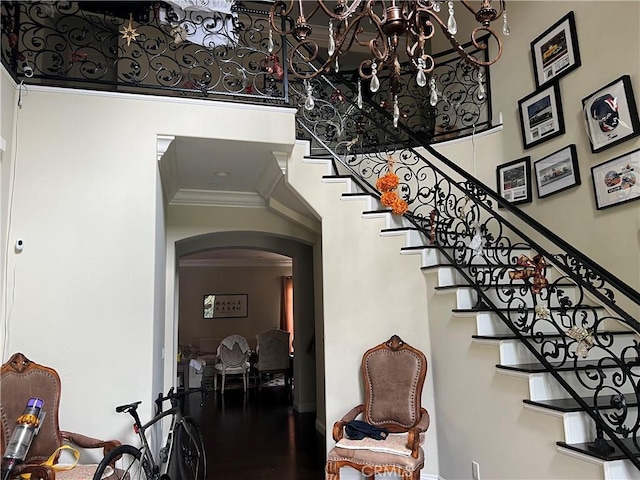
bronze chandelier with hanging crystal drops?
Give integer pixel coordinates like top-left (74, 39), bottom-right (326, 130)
top-left (268, 0), bottom-right (509, 126)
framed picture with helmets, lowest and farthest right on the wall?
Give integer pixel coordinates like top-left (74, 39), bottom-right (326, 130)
top-left (591, 149), bottom-right (640, 210)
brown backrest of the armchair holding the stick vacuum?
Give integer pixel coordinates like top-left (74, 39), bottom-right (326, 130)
top-left (0, 353), bottom-right (62, 464)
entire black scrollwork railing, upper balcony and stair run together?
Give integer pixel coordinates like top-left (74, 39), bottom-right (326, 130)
top-left (2, 2), bottom-right (640, 469)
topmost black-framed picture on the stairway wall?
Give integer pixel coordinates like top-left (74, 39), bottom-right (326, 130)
top-left (531, 12), bottom-right (581, 88)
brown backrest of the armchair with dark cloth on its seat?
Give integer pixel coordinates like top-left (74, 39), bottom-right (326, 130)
top-left (362, 335), bottom-right (427, 433)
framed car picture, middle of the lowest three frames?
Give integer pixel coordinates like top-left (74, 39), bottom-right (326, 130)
top-left (533, 144), bottom-right (580, 198)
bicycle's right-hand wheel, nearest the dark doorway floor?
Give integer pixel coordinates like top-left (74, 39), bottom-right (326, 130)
top-left (175, 417), bottom-right (207, 480)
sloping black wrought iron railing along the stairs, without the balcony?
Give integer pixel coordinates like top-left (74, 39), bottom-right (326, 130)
top-left (291, 77), bottom-right (640, 469)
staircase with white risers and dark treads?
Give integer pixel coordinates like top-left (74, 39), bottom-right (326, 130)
top-left (292, 134), bottom-right (640, 480)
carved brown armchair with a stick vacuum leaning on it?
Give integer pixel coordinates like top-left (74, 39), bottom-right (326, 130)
top-left (0, 353), bottom-right (120, 480)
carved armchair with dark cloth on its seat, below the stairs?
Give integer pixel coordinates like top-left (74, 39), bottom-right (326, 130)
top-left (326, 335), bottom-right (429, 480)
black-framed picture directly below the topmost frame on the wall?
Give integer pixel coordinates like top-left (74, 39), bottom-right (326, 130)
top-left (518, 83), bottom-right (564, 148)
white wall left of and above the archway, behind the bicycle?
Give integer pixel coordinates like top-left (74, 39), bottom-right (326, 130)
top-left (2, 82), bottom-right (302, 456)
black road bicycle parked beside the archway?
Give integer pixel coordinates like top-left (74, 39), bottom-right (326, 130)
top-left (93, 387), bottom-right (207, 480)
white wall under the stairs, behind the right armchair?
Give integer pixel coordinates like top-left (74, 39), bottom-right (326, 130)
top-left (287, 145), bottom-right (438, 475)
